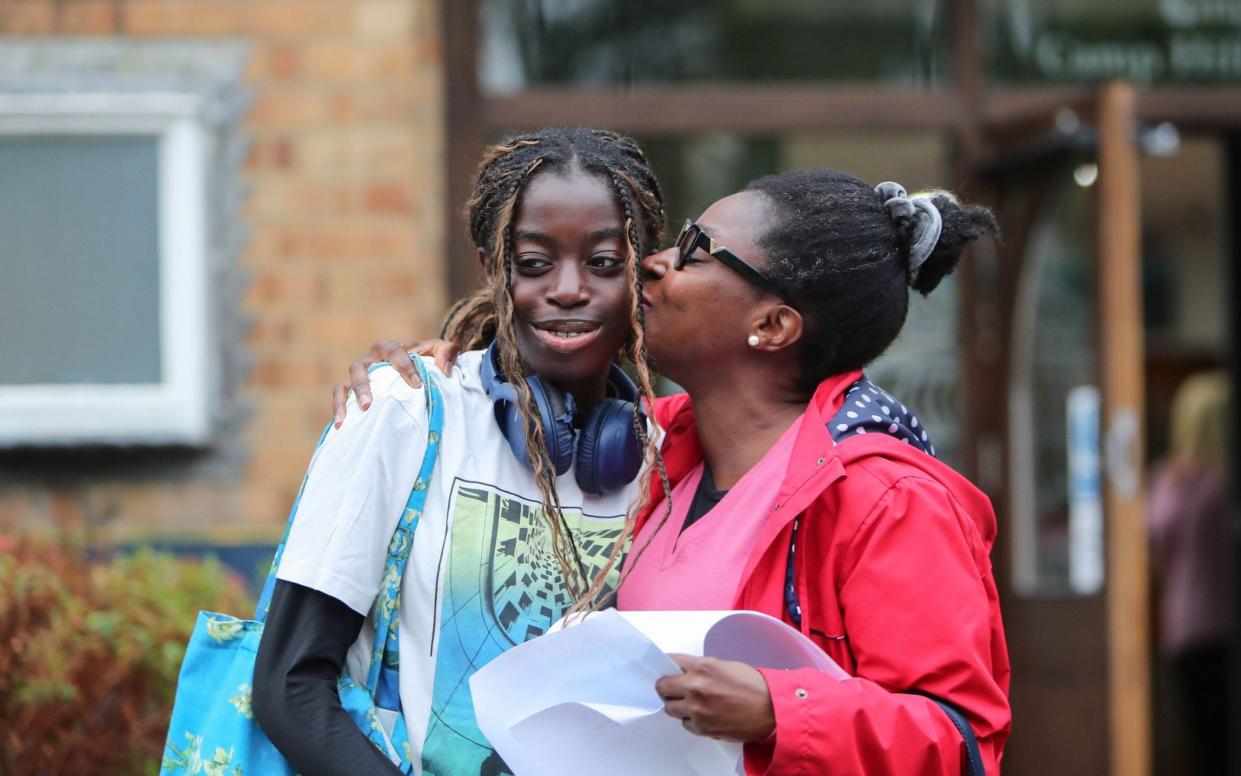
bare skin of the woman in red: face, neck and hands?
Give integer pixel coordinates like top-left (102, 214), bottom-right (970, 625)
top-left (335, 191), bottom-right (809, 742)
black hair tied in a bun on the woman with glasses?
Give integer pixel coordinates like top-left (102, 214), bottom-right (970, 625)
top-left (746, 169), bottom-right (998, 392)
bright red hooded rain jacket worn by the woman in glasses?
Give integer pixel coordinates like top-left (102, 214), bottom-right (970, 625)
top-left (638, 371), bottom-right (1010, 776)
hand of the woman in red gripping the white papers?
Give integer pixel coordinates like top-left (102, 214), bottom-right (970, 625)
top-left (655, 654), bottom-right (776, 742)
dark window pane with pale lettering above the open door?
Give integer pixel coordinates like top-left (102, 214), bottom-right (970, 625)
top-left (985, 0), bottom-right (1241, 83)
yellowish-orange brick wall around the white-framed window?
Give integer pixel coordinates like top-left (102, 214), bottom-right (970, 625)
top-left (0, 0), bottom-right (446, 541)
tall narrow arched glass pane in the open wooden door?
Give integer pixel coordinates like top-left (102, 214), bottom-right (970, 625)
top-left (1009, 173), bottom-right (1102, 593)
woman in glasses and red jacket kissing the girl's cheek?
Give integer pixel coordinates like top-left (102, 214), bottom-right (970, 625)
top-left (340, 170), bottom-right (1010, 776)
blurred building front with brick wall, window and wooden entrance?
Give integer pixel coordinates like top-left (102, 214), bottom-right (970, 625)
top-left (0, 0), bottom-right (1241, 776)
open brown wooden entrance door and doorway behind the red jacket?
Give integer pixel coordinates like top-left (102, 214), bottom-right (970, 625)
top-left (963, 86), bottom-right (1241, 776)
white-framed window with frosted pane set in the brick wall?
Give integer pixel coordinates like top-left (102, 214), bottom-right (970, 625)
top-left (0, 92), bottom-right (213, 447)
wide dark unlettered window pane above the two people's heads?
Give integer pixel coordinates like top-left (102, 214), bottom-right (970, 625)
top-left (479, 0), bottom-right (949, 94)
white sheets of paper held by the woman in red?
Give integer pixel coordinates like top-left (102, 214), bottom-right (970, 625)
top-left (470, 610), bottom-right (848, 776)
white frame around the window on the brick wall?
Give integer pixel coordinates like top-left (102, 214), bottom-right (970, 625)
top-left (0, 92), bottom-right (215, 447)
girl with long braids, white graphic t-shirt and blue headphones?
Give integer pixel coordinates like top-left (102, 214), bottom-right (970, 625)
top-left (245, 129), bottom-right (664, 776)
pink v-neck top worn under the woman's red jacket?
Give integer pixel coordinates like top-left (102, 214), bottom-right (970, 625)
top-left (617, 417), bottom-right (802, 610)
